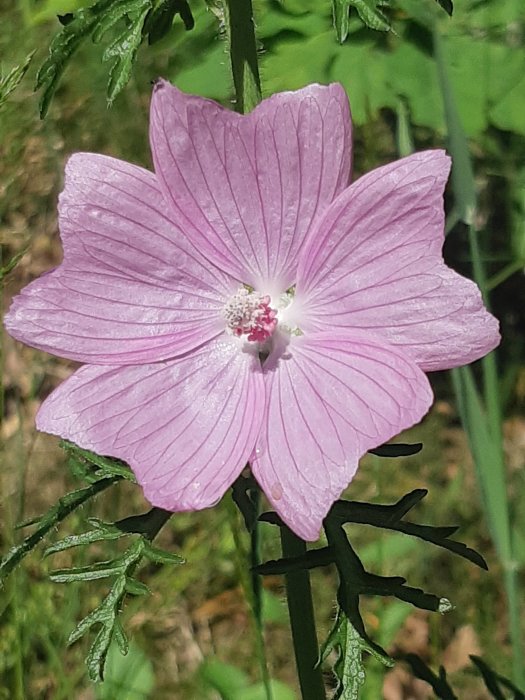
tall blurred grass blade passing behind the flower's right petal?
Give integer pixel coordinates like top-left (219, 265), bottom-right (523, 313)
top-left (433, 23), bottom-right (525, 686)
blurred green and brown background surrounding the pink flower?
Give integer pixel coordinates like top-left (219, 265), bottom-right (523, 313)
top-left (0, 0), bottom-right (525, 700)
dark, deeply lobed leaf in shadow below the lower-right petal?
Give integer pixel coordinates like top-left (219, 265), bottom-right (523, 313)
top-left (255, 492), bottom-right (487, 700)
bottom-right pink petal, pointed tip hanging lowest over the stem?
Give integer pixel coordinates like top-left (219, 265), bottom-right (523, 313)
top-left (252, 331), bottom-right (432, 540)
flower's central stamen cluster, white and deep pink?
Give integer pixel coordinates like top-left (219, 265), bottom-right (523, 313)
top-left (223, 287), bottom-right (277, 343)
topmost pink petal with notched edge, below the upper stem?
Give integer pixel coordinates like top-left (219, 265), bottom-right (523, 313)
top-left (150, 81), bottom-right (351, 293)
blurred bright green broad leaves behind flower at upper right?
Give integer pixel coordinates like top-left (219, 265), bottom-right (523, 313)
top-left (258, 0), bottom-right (525, 137)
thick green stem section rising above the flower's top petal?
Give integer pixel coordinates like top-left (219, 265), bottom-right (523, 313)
top-left (224, 0), bottom-right (261, 114)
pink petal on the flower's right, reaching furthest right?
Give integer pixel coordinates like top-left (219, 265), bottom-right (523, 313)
top-left (297, 151), bottom-right (499, 371)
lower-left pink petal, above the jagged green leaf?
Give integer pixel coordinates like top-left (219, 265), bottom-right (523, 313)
top-left (37, 337), bottom-right (264, 511)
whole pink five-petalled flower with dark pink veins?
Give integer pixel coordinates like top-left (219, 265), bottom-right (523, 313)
top-left (6, 81), bottom-right (499, 540)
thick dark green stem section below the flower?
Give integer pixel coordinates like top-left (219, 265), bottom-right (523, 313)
top-left (281, 527), bottom-right (326, 700)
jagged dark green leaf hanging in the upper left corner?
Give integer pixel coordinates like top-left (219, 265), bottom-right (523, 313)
top-left (36, 0), bottom-right (193, 117)
